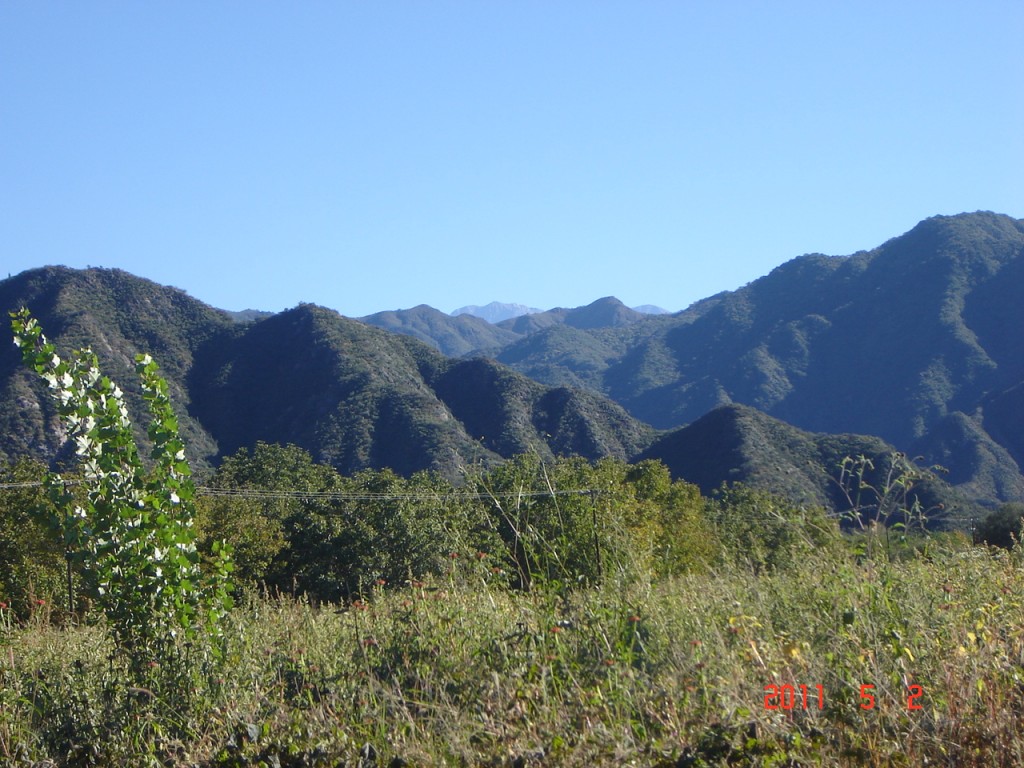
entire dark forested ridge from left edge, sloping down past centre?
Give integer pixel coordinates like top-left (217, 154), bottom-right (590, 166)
top-left (0, 267), bottom-right (653, 475)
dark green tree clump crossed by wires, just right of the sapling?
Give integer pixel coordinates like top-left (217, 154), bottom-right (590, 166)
top-left (199, 442), bottom-right (471, 601)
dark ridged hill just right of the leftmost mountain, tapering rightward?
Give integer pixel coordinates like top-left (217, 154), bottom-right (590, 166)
top-left (189, 305), bottom-right (652, 474)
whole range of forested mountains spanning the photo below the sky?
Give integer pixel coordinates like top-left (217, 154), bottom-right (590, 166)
top-left (0, 213), bottom-right (1024, 528)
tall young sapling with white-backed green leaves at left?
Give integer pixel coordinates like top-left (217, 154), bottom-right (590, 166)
top-left (11, 308), bottom-right (231, 672)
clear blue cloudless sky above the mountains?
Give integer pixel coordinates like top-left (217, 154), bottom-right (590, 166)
top-left (0, 0), bottom-right (1024, 316)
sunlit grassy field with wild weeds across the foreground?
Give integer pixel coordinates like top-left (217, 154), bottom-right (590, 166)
top-left (0, 544), bottom-right (1024, 768)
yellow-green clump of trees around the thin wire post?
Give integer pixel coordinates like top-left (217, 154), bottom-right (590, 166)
top-left (473, 455), bottom-right (715, 588)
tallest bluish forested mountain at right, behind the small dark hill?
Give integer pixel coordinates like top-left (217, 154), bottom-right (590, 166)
top-left (485, 213), bottom-right (1024, 507)
